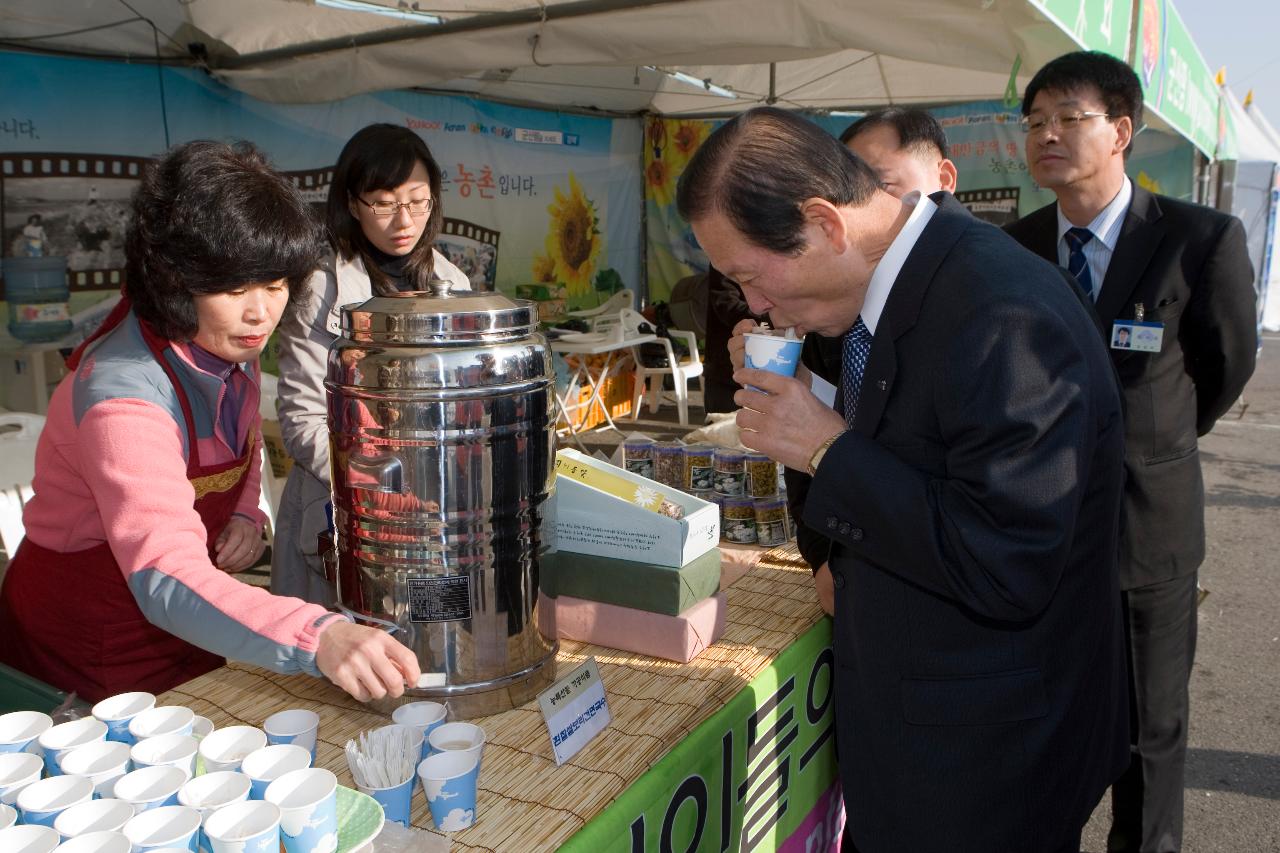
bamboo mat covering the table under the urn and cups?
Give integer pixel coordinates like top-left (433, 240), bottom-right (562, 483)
top-left (157, 546), bottom-right (829, 850)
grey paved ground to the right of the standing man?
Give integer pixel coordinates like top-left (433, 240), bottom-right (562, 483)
top-left (1083, 336), bottom-right (1280, 853)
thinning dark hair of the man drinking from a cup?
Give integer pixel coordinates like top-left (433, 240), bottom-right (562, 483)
top-left (676, 106), bottom-right (879, 255)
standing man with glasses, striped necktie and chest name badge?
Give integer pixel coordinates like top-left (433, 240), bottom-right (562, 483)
top-left (1009, 53), bottom-right (1257, 853)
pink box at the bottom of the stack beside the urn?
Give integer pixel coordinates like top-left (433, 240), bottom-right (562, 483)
top-left (538, 592), bottom-right (727, 663)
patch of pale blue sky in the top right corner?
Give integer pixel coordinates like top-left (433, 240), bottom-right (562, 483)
top-left (1175, 0), bottom-right (1280, 111)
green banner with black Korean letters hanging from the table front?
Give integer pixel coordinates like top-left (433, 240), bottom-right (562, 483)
top-left (561, 619), bottom-right (844, 853)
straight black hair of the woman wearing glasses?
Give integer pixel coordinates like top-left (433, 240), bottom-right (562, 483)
top-left (325, 124), bottom-right (444, 295)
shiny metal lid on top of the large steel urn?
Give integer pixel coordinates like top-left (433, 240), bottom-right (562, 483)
top-left (342, 279), bottom-right (538, 343)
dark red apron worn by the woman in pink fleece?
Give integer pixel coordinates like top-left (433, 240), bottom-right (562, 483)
top-left (0, 311), bottom-right (253, 702)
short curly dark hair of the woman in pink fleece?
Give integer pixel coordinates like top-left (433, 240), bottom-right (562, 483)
top-left (124, 140), bottom-right (323, 341)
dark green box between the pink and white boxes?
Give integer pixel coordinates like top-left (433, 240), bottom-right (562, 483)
top-left (538, 548), bottom-right (721, 616)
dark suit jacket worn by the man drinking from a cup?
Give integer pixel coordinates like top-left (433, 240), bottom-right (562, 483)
top-left (797, 193), bottom-right (1128, 853)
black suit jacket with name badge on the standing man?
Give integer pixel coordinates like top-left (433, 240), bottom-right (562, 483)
top-left (1007, 186), bottom-right (1257, 589)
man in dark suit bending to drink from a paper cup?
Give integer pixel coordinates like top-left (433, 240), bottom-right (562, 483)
top-left (677, 108), bottom-right (1128, 853)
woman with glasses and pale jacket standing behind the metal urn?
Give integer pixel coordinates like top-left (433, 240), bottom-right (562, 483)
top-left (271, 124), bottom-right (471, 606)
